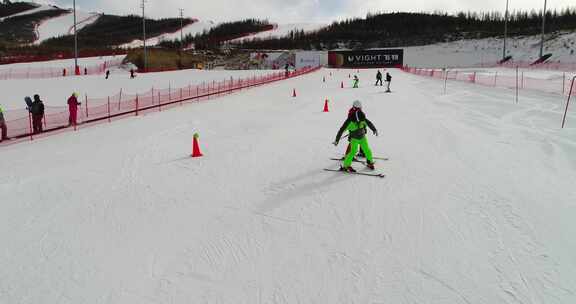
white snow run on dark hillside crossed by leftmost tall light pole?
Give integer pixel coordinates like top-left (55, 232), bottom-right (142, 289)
top-left (35, 11), bottom-right (100, 44)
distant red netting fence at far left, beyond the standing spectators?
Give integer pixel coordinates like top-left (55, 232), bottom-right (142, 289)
top-left (0, 59), bottom-right (122, 80)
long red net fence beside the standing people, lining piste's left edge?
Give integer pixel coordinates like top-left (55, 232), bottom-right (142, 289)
top-left (2, 67), bottom-right (320, 145)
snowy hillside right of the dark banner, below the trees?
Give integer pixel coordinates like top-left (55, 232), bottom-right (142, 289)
top-left (404, 32), bottom-right (576, 67)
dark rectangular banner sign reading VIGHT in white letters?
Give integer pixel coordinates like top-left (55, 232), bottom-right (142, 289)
top-left (328, 49), bottom-right (404, 68)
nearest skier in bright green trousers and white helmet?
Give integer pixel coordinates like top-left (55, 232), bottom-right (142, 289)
top-left (333, 100), bottom-right (378, 172)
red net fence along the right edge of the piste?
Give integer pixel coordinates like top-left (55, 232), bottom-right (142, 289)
top-left (401, 66), bottom-right (574, 96)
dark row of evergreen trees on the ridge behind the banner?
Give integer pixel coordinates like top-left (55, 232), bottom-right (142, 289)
top-left (236, 8), bottom-right (576, 49)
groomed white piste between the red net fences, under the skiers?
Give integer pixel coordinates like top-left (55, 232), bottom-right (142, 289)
top-left (0, 69), bottom-right (576, 304)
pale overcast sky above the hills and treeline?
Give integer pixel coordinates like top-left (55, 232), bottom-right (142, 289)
top-left (35, 0), bottom-right (576, 23)
